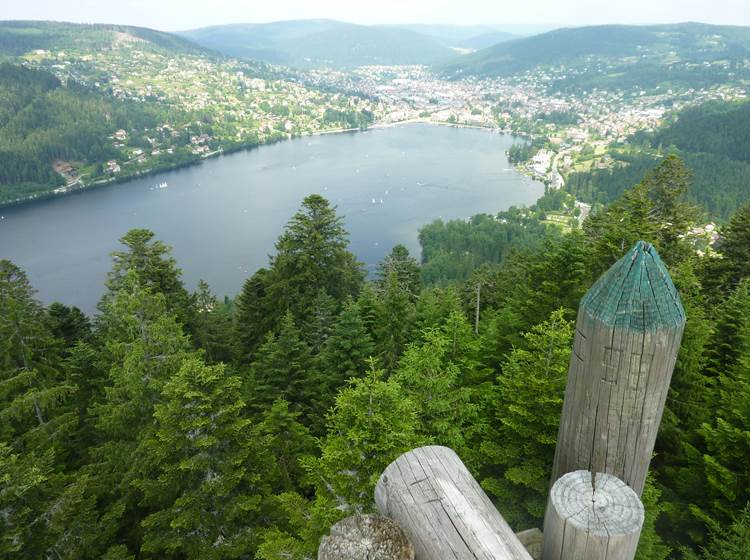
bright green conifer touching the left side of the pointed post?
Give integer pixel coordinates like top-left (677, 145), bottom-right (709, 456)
top-left (481, 310), bottom-right (573, 529)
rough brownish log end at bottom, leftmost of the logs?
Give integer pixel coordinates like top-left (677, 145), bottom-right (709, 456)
top-left (318, 514), bottom-right (414, 560)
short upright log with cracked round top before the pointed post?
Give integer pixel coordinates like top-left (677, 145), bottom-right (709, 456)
top-left (542, 471), bottom-right (644, 560)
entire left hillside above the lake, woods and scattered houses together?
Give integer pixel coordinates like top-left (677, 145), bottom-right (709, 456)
top-left (0, 21), bottom-right (378, 206)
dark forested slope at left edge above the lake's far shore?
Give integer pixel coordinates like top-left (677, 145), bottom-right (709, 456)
top-left (0, 63), bottom-right (167, 204)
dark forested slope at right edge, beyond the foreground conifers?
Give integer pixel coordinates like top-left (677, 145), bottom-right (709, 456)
top-left (566, 102), bottom-right (750, 220)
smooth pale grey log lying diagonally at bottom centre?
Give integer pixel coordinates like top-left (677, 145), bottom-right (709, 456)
top-left (375, 446), bottom-right (531, 560)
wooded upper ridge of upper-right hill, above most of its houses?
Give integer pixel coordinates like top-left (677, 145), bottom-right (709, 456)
top-left (442, 23), bottom-right (750, 76)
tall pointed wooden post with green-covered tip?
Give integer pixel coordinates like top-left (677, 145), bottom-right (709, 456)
top-left (550, 241), bottom-right (685, 496)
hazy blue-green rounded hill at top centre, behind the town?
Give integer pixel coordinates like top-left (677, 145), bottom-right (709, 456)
top-left (180, 20), bottom-right (456, 68)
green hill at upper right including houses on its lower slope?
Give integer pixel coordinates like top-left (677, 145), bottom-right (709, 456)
top-left (441, 23), bottom-right (750, 88)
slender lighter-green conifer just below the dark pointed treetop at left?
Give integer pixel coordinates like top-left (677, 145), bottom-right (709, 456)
top-left (84, 272), bottom-right (192, 552)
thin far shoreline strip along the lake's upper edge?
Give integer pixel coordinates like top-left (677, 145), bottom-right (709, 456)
top-left (0, 121), bottom-right (525, 210)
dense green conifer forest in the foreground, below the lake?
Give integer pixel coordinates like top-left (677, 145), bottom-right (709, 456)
top-left (0, 157), bottom-right (750, 560)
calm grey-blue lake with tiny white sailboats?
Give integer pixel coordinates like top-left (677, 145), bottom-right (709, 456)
top-left (0, 124), bottom-right (544, 312)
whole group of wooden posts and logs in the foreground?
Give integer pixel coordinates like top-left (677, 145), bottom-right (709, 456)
top-left (319, 242), bottom-right (685, 560)
